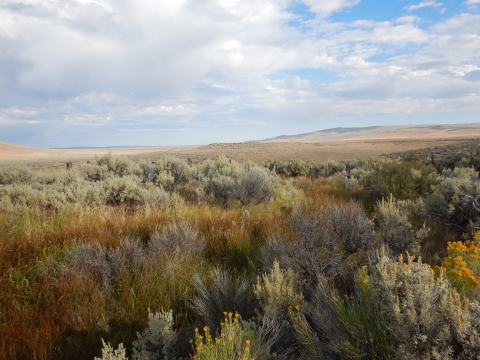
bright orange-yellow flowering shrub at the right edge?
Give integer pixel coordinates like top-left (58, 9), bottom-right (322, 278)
top-left (443, 232), bottom-right (480, 297)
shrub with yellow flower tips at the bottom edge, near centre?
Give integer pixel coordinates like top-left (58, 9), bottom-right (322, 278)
top-left (192, 312), bottom-right (270, 360)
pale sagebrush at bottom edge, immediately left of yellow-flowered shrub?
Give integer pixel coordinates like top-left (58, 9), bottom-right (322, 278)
top-left (132, 309), bottom-right (178, 360)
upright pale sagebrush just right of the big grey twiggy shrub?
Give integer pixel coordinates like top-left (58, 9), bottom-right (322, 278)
top-left (375, 196), bottom-right (429, 255)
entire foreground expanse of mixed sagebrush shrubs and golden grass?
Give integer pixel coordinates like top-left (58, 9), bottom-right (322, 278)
top-left (0, 141), bottom-right (480, 360)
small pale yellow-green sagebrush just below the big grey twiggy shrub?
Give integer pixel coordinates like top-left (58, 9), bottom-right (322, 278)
top-left (253, 260), bottom-right (305, 317)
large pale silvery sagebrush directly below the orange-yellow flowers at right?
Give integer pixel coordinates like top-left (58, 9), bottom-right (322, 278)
top-left (366, 255), bottom-right (480, 359)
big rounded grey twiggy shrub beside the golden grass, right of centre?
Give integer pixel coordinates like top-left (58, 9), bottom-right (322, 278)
top-left (261, 202), bottom-right (379, 279)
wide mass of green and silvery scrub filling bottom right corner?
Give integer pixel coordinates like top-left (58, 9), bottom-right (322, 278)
top-left (291, 249), bottom-right (480, 359)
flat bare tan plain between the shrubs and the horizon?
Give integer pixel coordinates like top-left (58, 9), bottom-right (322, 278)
top-left (0, 125), bottom-right (480, 170)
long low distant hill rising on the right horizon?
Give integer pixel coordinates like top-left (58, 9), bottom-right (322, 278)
top-left (256, 123), bottom-right (480, 142)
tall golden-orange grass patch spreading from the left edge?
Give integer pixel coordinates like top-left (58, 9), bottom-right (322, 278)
top-left (0, 181), bottom-right (299, 359)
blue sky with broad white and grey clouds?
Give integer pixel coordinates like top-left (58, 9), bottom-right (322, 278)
top-left (0, 0), bottom-right (480, 148)
